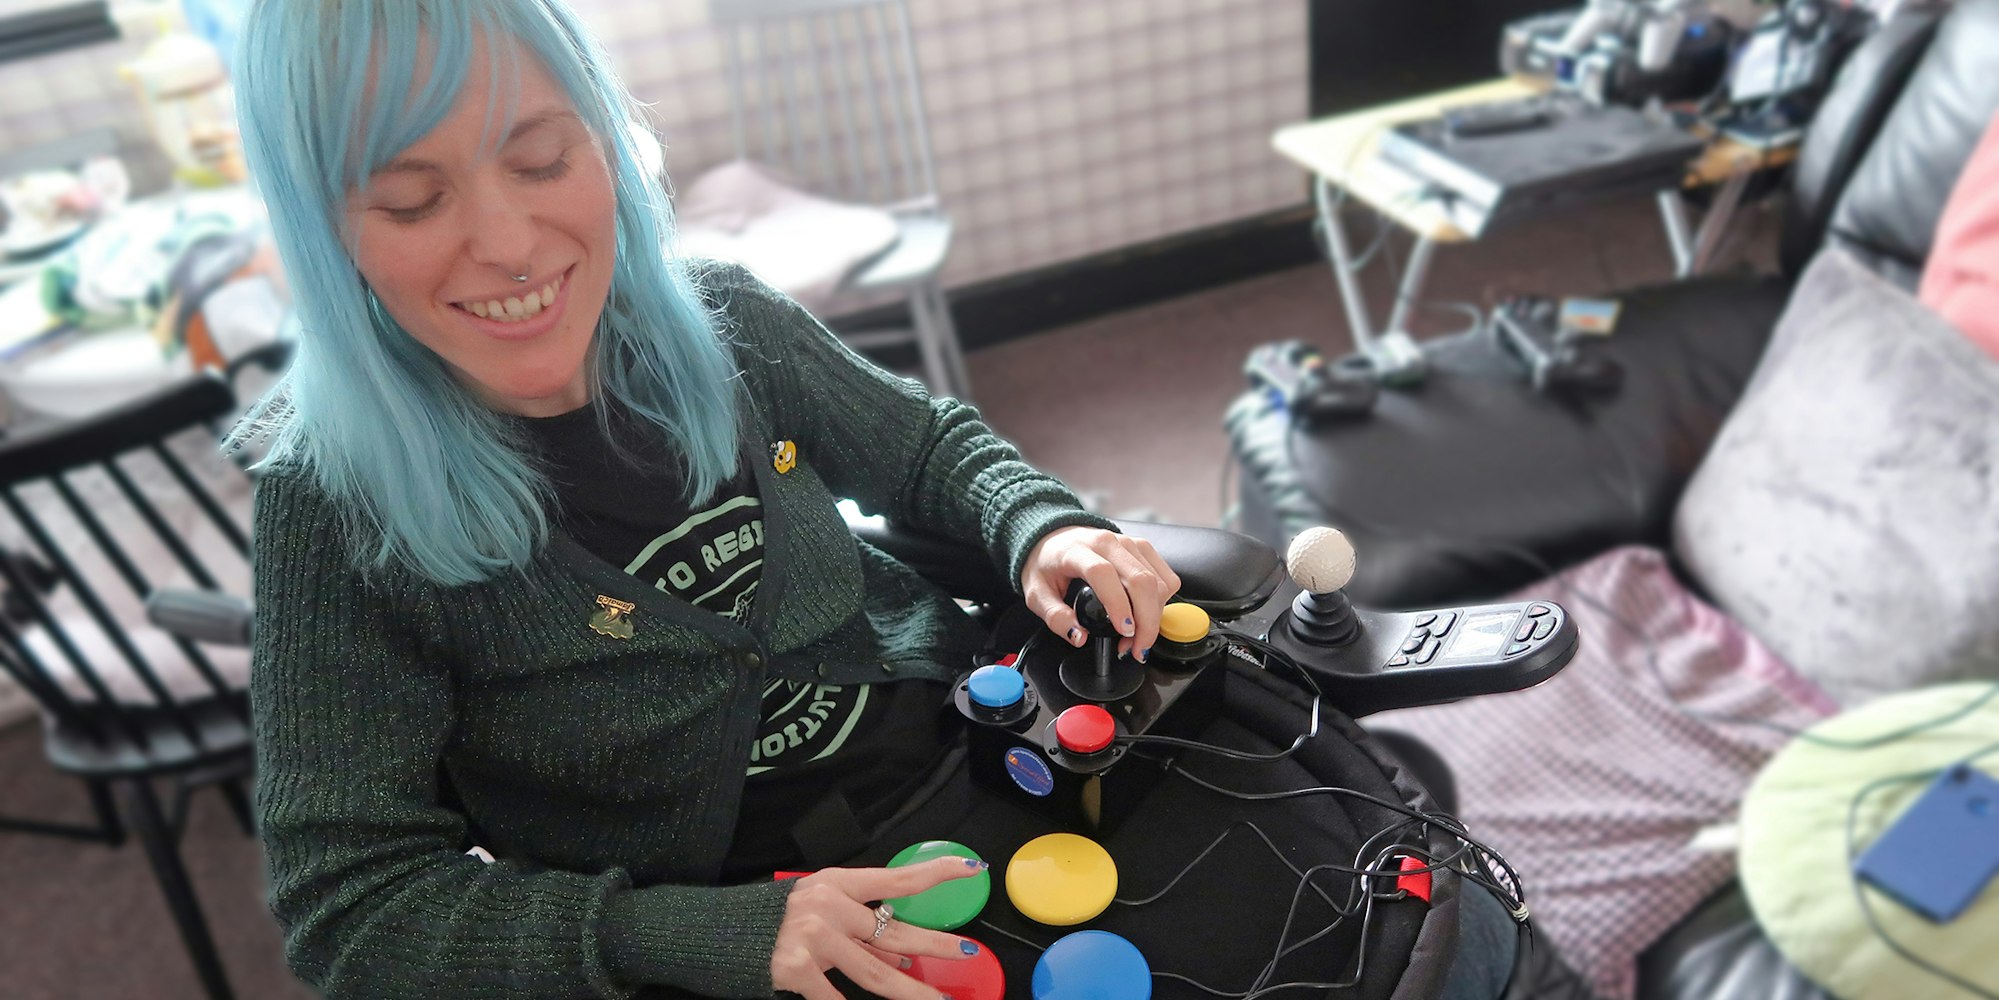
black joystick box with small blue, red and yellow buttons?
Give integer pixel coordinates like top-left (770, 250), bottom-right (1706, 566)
top-left (954, 588), bottom-right (1227, 832)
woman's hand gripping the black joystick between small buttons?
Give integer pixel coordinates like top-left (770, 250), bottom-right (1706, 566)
top-left (1019, 526), bottom-right (1179, 662)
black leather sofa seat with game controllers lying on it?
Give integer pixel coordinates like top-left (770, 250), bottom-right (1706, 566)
top-left (1229, 276), bottom-right (1787, 608)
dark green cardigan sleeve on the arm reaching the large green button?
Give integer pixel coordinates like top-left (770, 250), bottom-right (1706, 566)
top-left (250, 474), bottom-right (792, 1000)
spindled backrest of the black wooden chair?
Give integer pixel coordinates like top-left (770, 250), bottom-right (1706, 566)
top-left (0, 374), bottom-right (250, 748)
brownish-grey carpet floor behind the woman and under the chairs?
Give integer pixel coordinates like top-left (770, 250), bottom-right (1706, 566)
top-left (0, 191), bottom-right (1775, 1000)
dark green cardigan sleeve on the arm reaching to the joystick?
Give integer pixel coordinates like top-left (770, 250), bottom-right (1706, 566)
top-left (708, 264), bottom-right (1117, 590)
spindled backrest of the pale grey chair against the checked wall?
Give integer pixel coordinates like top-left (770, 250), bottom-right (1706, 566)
top-left (710, 0), bottom-right (938, 210)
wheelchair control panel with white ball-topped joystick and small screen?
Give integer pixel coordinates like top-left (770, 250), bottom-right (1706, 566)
top-left (1269, 528), bottom-right (1577, 718)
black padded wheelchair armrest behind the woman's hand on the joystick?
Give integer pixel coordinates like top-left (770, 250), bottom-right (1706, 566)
top-left (852, 520), bottom-right (1283, 620)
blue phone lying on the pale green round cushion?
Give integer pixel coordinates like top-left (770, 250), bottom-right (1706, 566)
top-left (1853, 764), bottom-right (1999, 924)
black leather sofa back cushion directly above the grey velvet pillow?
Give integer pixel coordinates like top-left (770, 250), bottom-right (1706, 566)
top-left (1829, 0), bottom-right (1999, 290)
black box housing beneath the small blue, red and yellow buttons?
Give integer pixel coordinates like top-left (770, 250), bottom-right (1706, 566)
top-left (954, 632), bottom-right (1227, 834)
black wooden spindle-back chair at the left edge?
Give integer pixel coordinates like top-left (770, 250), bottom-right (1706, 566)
top-left (0, 376), bottom-right (252, 1000)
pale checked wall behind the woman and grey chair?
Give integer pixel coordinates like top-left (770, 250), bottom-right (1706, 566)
top-left (0, 0), bottom-right (1307, 284)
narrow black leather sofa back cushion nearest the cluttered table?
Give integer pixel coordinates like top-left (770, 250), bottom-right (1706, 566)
top-left (1779, 10), bottom-right (1939, 278)
